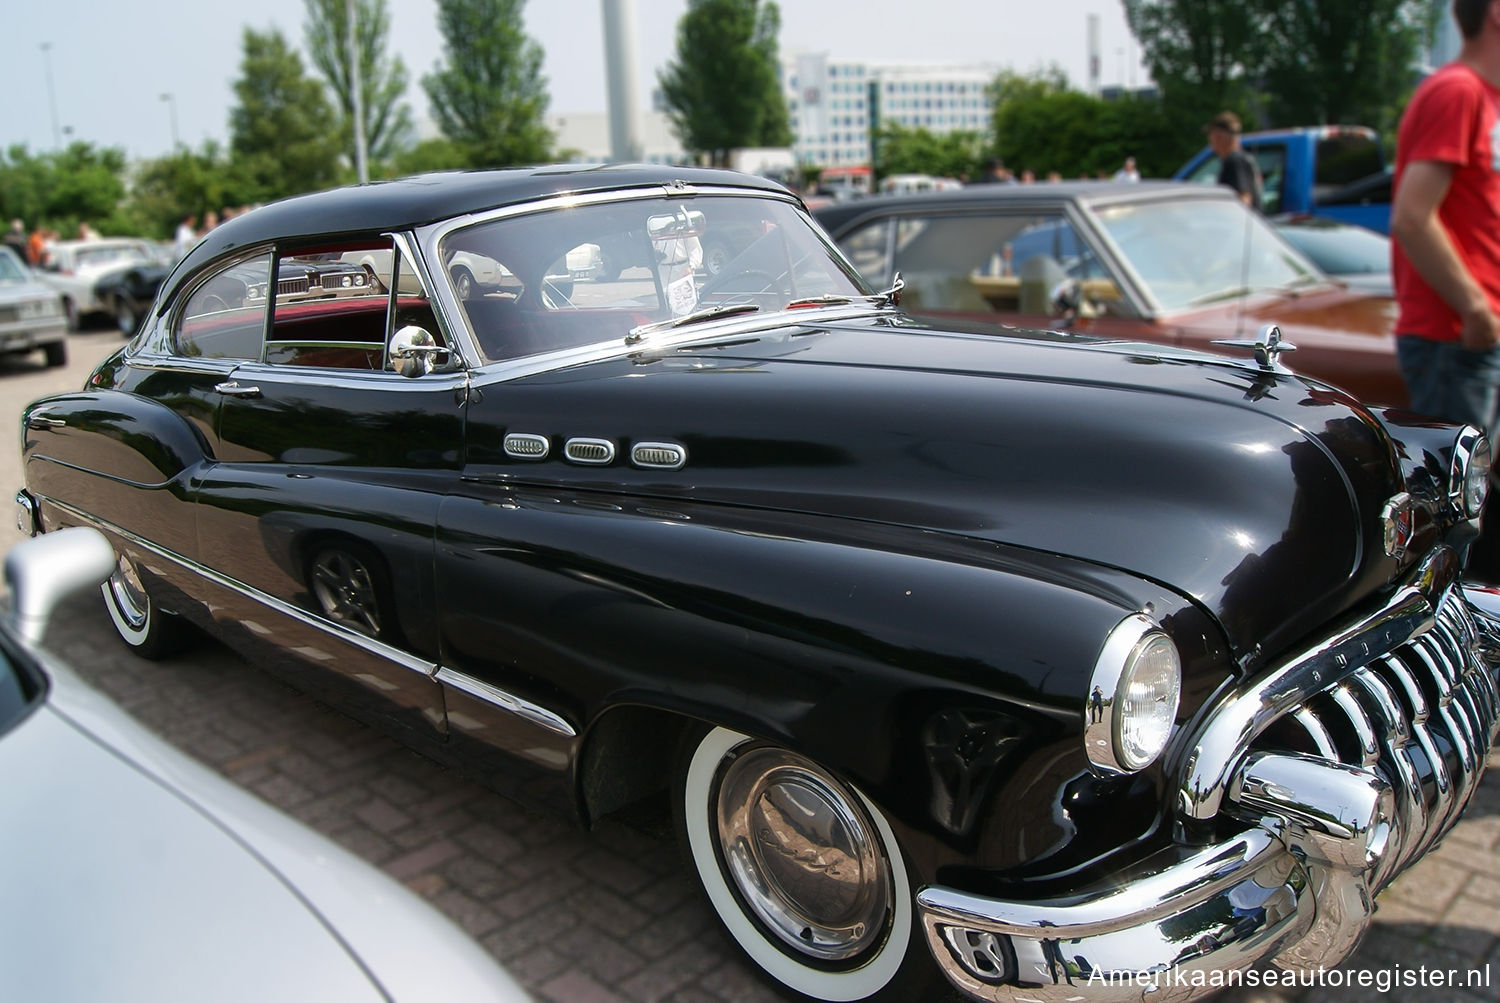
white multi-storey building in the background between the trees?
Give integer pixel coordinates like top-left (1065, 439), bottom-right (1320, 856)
top-left (782, 52), bottom-right (999, 166)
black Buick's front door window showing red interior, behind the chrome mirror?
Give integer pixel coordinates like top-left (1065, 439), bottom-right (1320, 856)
top-left (266, 237), bottom-right (416, 370)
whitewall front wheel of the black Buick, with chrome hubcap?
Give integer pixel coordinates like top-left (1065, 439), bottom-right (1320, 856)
top-left (677, 727), bottom-right (942, 1003)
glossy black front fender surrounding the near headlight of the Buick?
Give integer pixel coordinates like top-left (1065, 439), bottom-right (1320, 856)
top-left (438, 489), bottom-right (1229, 873)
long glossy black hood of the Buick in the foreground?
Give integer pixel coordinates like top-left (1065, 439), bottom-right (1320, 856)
top-left (492, 318), bottom-right (1401, 668)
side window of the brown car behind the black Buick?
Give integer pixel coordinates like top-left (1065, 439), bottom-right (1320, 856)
top-left (896, 213), bottom-right (1121, 316)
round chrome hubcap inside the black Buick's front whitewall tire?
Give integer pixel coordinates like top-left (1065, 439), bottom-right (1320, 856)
top-left (714, 747), bottom-right (893, 961)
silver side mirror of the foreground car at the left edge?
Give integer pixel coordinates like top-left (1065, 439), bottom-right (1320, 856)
top-left (5, 526), bottom-right (116, 645)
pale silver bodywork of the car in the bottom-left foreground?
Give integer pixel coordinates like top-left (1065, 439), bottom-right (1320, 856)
top-left (0, 664), bottom-right (525, 1003)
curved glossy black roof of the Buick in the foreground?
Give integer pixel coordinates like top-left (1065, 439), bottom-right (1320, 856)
top-left (165, 163), bottom-right (788, 297)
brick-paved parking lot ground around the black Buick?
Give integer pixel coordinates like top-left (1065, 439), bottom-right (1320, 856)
top-left (0, 331), bottom-right (1500, 1003)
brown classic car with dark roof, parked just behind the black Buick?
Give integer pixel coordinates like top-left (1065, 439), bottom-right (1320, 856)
top-left (815, 181), bottom-right (1407, 406)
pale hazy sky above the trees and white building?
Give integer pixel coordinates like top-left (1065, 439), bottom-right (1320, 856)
top-left (0, 0), bottom-right (1148, 159)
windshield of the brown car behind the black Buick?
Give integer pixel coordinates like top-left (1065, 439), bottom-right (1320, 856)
top-left (1097, 199), bottom-right (1323, 312)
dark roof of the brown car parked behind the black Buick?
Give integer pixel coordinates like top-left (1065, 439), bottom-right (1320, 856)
top-left (813, 181), bottom-right (1235, 232)
